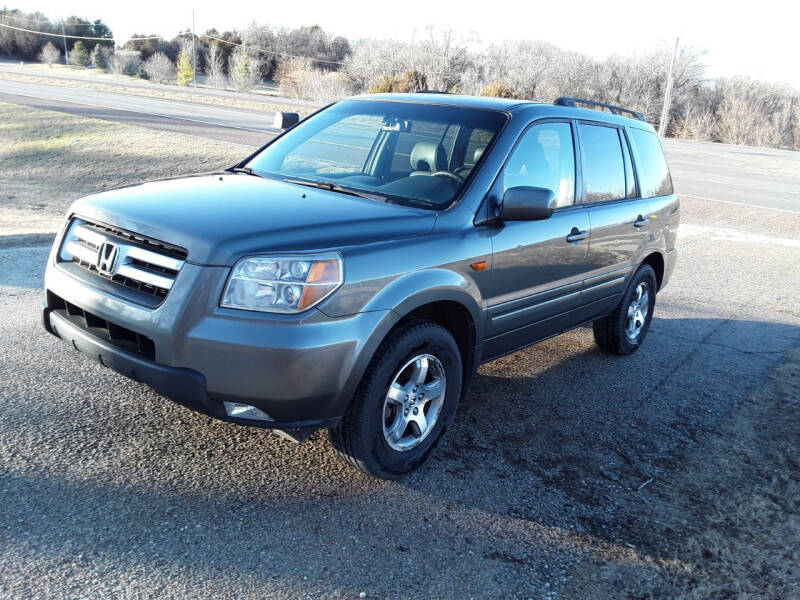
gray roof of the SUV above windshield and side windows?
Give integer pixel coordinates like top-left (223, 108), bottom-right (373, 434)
top-left (348, 92), bottom-right (652, 129)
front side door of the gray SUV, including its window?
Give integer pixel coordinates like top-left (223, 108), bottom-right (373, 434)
top-left (485, 120), bottom-right (590, 358)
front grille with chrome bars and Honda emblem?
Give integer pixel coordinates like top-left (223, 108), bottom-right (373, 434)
top-left (59, 218), bottom-right (187, 305)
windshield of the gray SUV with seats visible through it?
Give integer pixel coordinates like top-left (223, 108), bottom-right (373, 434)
top-left (247, 100), bottom-right (506, 209)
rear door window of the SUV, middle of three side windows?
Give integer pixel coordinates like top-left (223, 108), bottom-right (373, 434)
top-left (580, 125), bottom-right (625, 202)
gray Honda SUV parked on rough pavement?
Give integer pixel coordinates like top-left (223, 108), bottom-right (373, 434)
top-left (43, 93), bottom-right (679, 478)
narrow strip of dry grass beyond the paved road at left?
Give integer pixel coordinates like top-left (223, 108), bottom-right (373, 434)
top-left (0, 67), bottom-right (316, 117)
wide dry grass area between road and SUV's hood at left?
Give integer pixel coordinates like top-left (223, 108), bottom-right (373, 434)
top-left (0, 103), bottom-right (252, 239)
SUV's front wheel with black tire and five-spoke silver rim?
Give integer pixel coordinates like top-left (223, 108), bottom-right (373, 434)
top-left (329, 320), bottom-right (463, 479)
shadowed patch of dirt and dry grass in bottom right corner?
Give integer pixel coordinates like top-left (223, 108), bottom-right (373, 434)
top-left (565, 350), bottom-right (800, 599)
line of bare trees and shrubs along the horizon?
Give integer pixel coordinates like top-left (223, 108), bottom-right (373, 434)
top-left (0, 10), bottom-right (800, 149)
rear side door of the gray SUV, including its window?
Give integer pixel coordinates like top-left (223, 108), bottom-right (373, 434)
top-left (578, 121), bottom-right (650, 311)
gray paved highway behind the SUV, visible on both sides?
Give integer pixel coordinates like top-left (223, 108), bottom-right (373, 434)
top-left (0, 79), bottom-right (800, 214)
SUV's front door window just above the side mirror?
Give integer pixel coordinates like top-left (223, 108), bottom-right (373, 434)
top-left (503, 123), bottom-right (575, 206)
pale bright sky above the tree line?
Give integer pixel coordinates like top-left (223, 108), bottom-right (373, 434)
top-left (18, 0), bottom-right (800, 88)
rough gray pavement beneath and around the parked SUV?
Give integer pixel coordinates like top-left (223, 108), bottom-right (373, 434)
top-left (0, 195), bottom-right (800, 599)
